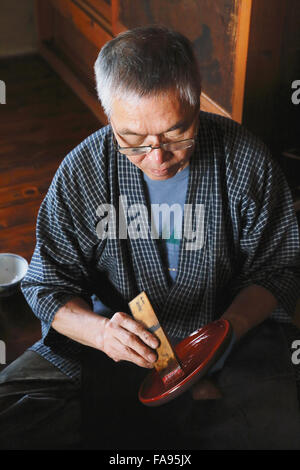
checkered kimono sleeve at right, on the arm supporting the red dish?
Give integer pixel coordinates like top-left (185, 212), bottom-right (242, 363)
top-left (234, 149), bottom-right (300, 321)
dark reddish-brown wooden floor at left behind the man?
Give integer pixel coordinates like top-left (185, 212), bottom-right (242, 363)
top-left (0, 55), bottom-right (101, 370)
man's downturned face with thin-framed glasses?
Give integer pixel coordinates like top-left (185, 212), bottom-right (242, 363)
top-left (110, 91), bottom-right (199, 180)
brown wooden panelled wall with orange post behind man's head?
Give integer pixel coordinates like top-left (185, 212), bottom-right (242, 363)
top-left (36, 0), bottom-right (300, 158)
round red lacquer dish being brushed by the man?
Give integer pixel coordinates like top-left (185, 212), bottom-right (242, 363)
top-left (139, 319), bottom-right (232, 406)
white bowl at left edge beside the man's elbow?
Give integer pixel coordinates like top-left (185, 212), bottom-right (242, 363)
top-left (0, 253), bottom-right (28, 297)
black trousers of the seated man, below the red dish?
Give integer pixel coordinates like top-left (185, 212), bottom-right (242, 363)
top-left (0, 321), bottom-right (300, 450)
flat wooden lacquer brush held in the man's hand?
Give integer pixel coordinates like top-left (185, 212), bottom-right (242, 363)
top-left (129, 292), bottom-right (184, 384)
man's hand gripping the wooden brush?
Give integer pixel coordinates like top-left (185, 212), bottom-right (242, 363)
top-left (101, 312), bottom-right (159, 369)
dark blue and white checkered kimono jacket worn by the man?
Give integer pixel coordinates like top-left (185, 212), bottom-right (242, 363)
top-left (21, 112), bottom-right (300, 380)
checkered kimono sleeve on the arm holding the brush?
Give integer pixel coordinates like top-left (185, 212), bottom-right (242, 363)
top-left (21, 163), bottom-right (92, 337)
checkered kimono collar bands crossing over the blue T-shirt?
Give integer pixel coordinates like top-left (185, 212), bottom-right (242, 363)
top-left (117, 119), bottom-right (212, 335)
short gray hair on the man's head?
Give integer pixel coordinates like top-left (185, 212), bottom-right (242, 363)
top-left (94, 25), bottom-right (201, 117)
